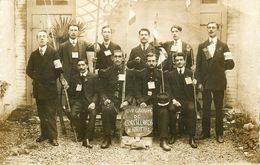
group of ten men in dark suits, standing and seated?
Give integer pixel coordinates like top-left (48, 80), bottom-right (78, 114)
top-left (26, 22), bottom-right (234, 151)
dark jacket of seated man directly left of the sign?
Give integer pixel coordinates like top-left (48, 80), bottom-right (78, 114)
top-left (98, 65), bottom-right (134, 103)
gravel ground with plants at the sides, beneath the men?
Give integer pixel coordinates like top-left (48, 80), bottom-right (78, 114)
top-left (0, 108), bottom-right (260, 165)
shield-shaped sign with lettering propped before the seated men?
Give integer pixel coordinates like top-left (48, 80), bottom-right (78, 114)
top-left (124, 106), bottom-right (153, 137)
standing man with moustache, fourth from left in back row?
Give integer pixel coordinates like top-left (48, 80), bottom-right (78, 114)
top-left (127, 28), bottom-right (155, 69)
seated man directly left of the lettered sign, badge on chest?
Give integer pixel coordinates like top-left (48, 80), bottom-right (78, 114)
top-left (99, 50), bottom-right (134, 149)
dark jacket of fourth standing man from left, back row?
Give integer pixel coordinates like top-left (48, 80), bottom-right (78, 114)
top-left (127, 44), bottom-right (155, 70)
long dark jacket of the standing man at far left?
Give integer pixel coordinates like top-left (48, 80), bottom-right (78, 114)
top-left (26, 46), bottom-right (59, 99)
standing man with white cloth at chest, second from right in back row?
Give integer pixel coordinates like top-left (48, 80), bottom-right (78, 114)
top-left (162, 25), bottom-right (193, 71)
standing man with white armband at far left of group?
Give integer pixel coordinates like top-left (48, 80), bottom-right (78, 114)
top-left (26, 30), bottom-right (61, 146)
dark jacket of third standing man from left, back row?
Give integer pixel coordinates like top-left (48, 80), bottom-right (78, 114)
top-left (96, 41), bottom-right (121, 69)
